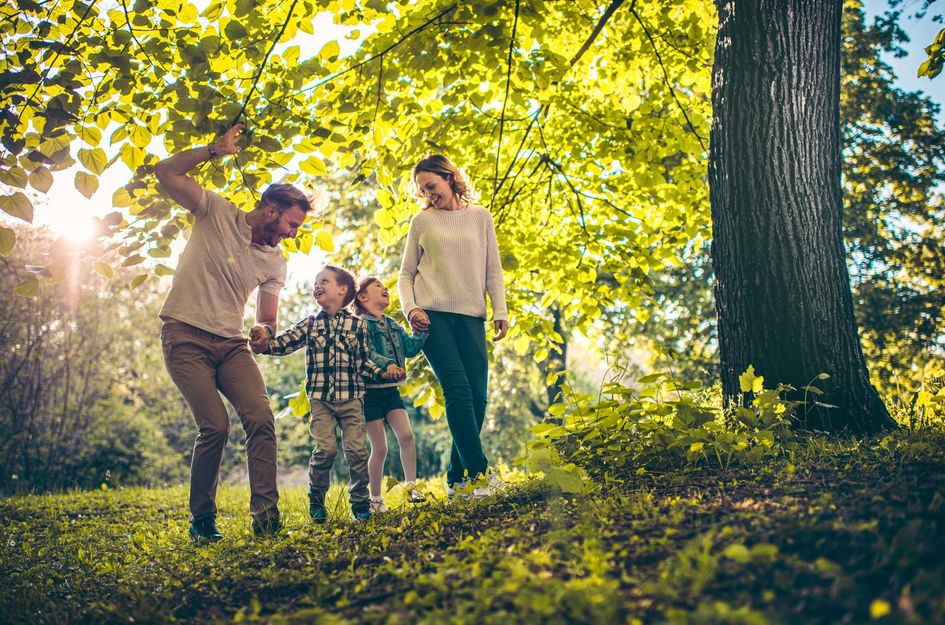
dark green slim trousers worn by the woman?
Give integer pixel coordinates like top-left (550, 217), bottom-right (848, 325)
top-left (423, 310), bottom-right (489, 484)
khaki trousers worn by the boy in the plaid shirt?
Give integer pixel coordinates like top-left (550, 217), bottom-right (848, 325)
top-left (308, 398), bottom-right (370, 511)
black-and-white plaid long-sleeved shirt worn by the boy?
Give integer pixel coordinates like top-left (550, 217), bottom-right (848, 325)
top-left (263, 309), bottom-right (383, 403)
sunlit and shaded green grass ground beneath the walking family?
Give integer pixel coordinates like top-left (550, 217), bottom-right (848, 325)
top-left (0, 432), bottom-right (945, 625)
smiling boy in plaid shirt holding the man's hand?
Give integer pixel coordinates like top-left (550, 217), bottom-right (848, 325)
top-left (250, 265), bottom-right (391, 523)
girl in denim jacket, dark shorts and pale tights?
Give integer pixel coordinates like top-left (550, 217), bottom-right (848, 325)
top-left (352, 276), bottom-right (428, 512)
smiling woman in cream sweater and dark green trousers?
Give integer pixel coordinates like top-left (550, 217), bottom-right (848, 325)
top-left (399, 154), bottom-right (509, 497)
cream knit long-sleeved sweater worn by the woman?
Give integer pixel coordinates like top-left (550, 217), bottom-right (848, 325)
top-left (399, 206), bottom-right (509, 321)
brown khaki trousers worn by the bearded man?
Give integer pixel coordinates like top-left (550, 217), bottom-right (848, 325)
top-left (161, 321), bottom-right (279, 520)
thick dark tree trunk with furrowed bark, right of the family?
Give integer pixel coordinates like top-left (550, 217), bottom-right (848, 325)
top-left (709, 0), bottom-right (895, 433)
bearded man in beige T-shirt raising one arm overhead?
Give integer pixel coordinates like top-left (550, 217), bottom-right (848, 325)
top-left (155, 124), bottom-right (312, 543)
